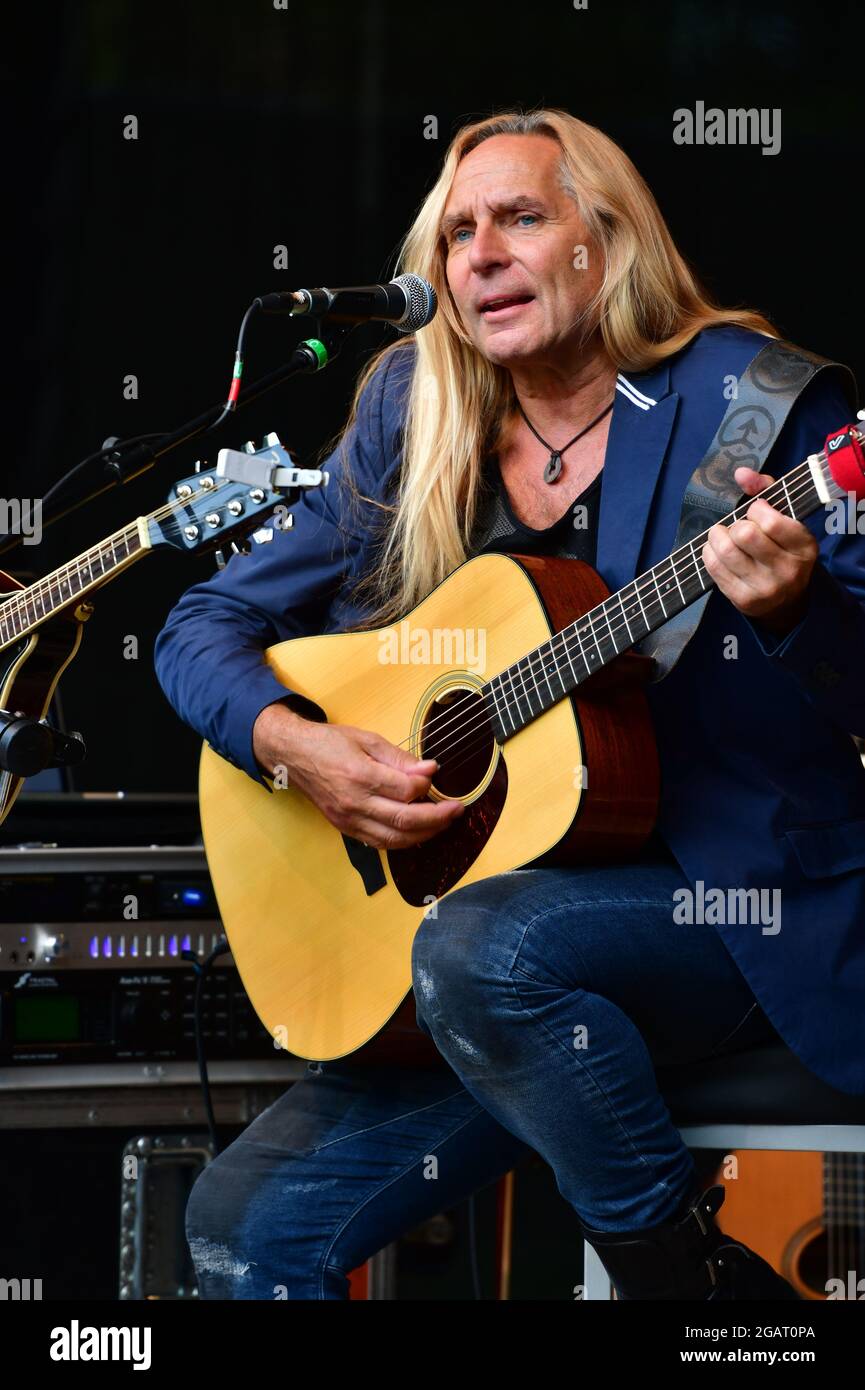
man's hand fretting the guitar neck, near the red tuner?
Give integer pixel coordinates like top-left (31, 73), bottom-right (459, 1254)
top-left (702, 468), bottom-right (819, 637)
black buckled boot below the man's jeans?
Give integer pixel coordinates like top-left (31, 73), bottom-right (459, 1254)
top-left (581, 1186), bottom-right (801, 1302)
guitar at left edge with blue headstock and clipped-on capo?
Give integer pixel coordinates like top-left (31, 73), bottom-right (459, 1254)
top-left (0, 447), bottom-right (285, 824)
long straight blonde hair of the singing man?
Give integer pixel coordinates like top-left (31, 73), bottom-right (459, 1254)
top-left (332, 108), bottom-right (779, 627)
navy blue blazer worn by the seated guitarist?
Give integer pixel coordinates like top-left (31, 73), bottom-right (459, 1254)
top-left (156, 328), bottom-right (865, 1094)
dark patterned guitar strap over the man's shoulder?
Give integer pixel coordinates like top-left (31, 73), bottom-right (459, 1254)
top-left (637, 339), bottom-right (858, 682)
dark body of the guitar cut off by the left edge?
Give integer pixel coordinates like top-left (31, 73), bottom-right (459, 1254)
top-left (0, 570), bottom-right (90, 824)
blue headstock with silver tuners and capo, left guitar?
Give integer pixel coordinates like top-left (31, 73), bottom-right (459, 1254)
top-left (145, 435), bottom-right (292, 552)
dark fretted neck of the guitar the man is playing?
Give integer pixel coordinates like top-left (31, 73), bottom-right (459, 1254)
top-left (483, 452), bottom-right (844, 744)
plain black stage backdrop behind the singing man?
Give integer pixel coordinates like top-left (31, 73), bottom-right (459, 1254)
top-left (0, 0), bottom-right (865, 791)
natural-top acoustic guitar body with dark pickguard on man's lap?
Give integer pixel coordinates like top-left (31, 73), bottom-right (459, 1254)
top-left (200, 555), bottom-right (658, 1061)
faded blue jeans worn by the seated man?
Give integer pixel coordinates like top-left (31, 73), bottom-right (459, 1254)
top-left (186, 853), bottom-right (777, 1298)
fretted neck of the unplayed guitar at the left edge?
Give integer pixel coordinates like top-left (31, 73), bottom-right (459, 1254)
top-left (0, 517), bottom-right (150, 649)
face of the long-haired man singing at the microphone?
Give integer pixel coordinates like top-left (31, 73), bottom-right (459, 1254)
top-left (442, 135), bottom-right (604, 366)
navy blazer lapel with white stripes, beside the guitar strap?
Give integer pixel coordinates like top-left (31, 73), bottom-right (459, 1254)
top-left (597, 363), bottom-right (679, 592)
